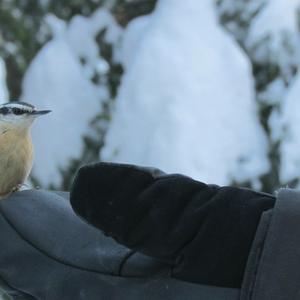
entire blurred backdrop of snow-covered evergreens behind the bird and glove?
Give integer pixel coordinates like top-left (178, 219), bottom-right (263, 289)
top-left (0, 0), bottom-right (300, 191)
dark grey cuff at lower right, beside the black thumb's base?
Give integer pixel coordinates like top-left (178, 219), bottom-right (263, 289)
top-left (241, 189), bottom-right (300, 300)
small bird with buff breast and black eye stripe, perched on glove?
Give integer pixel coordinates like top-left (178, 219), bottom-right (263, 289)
top-left (0, 101), bottom-right (51, 199)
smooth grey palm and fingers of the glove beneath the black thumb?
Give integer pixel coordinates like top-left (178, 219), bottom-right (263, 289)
top-left (0, 190), bottom-right (239, 300)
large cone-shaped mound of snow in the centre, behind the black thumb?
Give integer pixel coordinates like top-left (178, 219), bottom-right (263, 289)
top-left (101, 0), bottom-right (269, 184)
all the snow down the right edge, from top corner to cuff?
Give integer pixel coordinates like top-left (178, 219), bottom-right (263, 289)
top-left (248, 0), bottom-right (300, 184)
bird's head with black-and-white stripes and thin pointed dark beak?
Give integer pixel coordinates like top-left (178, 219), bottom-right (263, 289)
top-left (0, 101), bottom-right (51, 131)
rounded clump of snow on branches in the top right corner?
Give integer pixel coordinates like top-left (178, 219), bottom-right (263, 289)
top-left (247, 0), bottom-right (300, 76)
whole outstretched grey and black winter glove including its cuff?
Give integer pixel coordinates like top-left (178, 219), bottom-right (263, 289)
top-left (0, 163), bottom-right (300, 300)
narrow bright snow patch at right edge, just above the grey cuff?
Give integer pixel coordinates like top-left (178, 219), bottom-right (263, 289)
top-left (279, 74), bottom-right (300, 183)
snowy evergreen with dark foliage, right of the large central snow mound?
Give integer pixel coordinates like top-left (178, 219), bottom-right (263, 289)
top-left (218, 0), bottom-right (300, 191)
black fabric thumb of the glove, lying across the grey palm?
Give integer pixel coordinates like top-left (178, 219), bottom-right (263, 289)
top-left (71, 163), bottom-right (275, 288)
